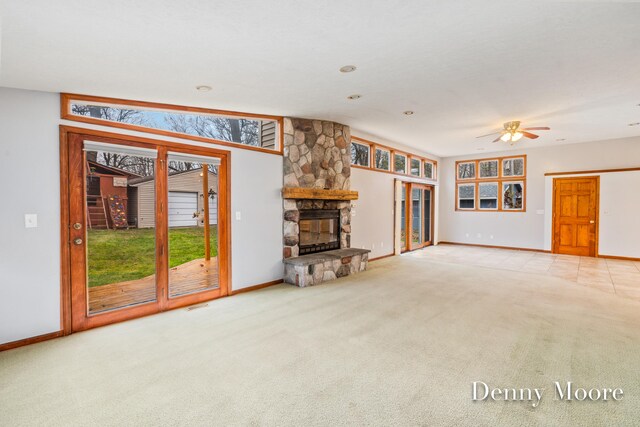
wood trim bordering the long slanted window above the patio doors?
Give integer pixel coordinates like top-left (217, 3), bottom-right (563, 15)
top-left (60, 93), bottom-right (284, 156)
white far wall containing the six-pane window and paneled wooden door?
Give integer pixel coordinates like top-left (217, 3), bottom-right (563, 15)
top-left (440, 138), bottom-right (640, 257)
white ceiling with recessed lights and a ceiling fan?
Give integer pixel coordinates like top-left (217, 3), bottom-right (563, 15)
top-left (0, 0), bottom-right (640, 156)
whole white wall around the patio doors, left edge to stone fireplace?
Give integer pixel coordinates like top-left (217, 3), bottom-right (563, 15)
top-left (0, 88), bottom-right (283, 344)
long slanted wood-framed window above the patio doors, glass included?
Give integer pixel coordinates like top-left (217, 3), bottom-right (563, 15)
top-left (61, 94), bottom-right (282, 154)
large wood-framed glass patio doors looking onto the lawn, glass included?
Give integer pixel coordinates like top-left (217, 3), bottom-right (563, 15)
top-left (61, 131), bottom-right (230, 333)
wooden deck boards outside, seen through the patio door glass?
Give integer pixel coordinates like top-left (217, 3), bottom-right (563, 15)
top-left (89, 258), bottom-right (219, 314)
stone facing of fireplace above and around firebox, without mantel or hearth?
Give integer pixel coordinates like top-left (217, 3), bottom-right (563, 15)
top-left (283, 117), bottom-right (351, 258)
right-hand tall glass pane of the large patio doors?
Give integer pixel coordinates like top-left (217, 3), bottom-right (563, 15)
top-left (167, 160), bottom-right (218, 297)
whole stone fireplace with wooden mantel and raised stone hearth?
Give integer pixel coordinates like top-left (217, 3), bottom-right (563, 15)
top-left (282, 118), bottom-right (369, 286)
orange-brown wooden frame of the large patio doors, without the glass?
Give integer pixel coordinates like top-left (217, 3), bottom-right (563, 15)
top-left (59, 125), bottom-right (231, 335)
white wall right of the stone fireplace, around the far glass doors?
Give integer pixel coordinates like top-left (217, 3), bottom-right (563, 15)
top-left (351, 166), bottom-right (439, 258)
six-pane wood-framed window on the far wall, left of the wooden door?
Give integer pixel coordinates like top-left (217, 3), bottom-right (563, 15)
top-left (456, 155), bottom-right (527, 212)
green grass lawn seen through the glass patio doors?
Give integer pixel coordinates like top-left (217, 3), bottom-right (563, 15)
top-left (88, 225), bottom-right (218, 287)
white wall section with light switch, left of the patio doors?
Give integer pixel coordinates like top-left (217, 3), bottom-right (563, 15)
top-left (0, 88), bottom-right (60, 343)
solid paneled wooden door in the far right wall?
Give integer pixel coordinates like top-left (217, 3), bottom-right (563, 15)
top-left (552, 176), bottom-right (600, 257)
